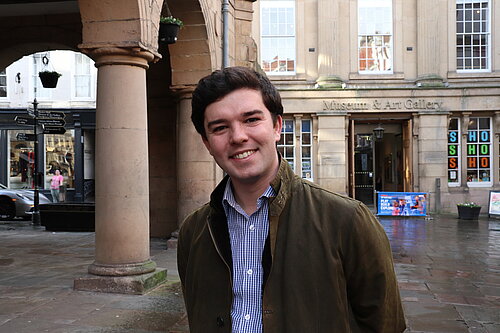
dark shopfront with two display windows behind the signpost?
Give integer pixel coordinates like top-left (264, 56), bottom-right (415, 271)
top-left (0, 109), bottom-right (95, 201)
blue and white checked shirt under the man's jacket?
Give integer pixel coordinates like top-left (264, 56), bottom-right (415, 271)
top-left (222, 180), bottom-right (276, 333)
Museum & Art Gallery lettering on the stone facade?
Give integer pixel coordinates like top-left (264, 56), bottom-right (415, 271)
top-left (323, 98), bottom-right (443, 111)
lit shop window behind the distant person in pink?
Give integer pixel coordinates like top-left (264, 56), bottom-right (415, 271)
top-left (44, 130), bottom-right (75, 189)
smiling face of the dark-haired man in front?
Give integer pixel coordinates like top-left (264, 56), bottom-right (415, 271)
top-left (203, 89), bottom-right (282, 185)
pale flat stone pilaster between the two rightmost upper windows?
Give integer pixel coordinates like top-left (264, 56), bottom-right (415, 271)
top-left (416, 0), bottom-right (448, 87)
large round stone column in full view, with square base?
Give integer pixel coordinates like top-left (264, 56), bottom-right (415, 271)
top-left (75, 48), bottom-right (166, 293)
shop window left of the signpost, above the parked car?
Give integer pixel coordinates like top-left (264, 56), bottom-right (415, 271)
top-left (8, 130), bottom-right (35, 189)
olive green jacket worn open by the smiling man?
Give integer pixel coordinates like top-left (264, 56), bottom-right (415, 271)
top-left (178, 159), bottom-right (405, 333)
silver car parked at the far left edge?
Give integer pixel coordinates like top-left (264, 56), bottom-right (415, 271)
top-left (0, 184), bottom-right (50, 220)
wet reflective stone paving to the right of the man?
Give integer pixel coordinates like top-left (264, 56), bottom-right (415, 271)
top-left (380, 216), bottom-right (500, 333)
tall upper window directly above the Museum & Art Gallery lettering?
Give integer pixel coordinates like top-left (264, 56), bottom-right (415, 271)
top-left (358, 0), bottom-right (393, 74)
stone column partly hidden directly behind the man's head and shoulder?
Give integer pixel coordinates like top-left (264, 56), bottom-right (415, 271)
top-left (177, 94), bottom-right (222, 225)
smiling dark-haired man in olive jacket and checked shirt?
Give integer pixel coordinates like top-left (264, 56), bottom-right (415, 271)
top-left (178, 67), bottom-right (405, 333)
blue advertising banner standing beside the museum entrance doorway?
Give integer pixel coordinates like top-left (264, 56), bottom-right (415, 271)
top-left (377, 192), bottom-right (428, 216)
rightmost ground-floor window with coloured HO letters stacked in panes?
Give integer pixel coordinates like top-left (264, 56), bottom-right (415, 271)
top-left (467, 118), bottom-right (492, 186)
